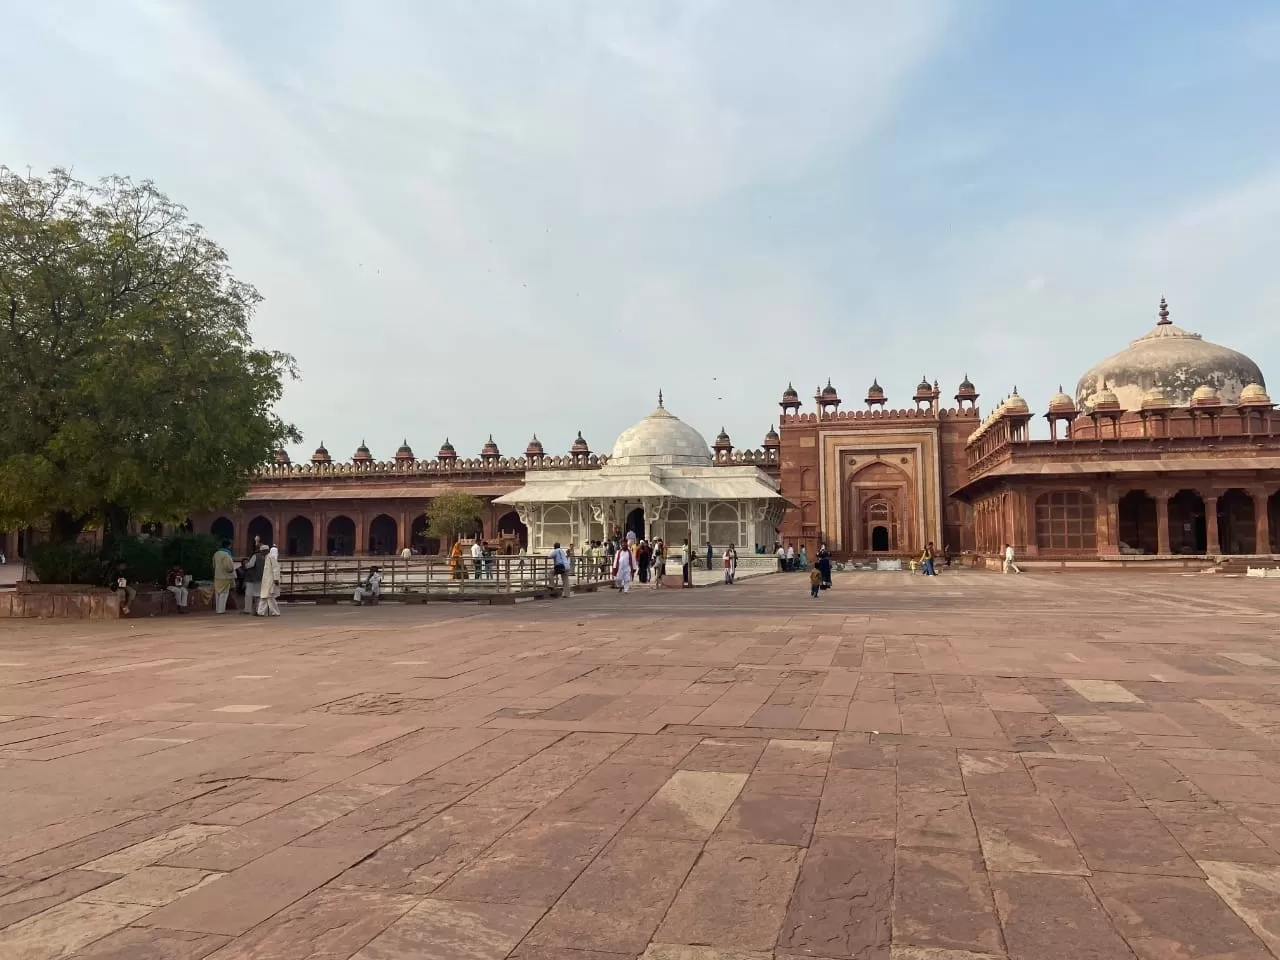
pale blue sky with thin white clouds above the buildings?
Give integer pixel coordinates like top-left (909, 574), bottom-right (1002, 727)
top-left (0, 0), bottom-right (1280, 458)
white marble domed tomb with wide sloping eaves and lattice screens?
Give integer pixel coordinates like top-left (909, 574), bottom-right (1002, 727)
top-left (497, 394), bottom-right (787, 553)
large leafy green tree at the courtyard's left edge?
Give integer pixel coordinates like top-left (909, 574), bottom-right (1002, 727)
top-left (0, 166), bottom-right (298, 541)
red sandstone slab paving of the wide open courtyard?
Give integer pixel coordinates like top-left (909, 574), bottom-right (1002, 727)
top-left (0, 572), bottom-right (1280, 960)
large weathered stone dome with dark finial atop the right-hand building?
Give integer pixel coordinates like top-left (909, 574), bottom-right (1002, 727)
top-left (1075, 301), bottom-right (1266, 410)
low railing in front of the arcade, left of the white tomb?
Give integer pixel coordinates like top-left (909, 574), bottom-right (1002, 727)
top-left (273, 556), bottom-right (611, 603)
